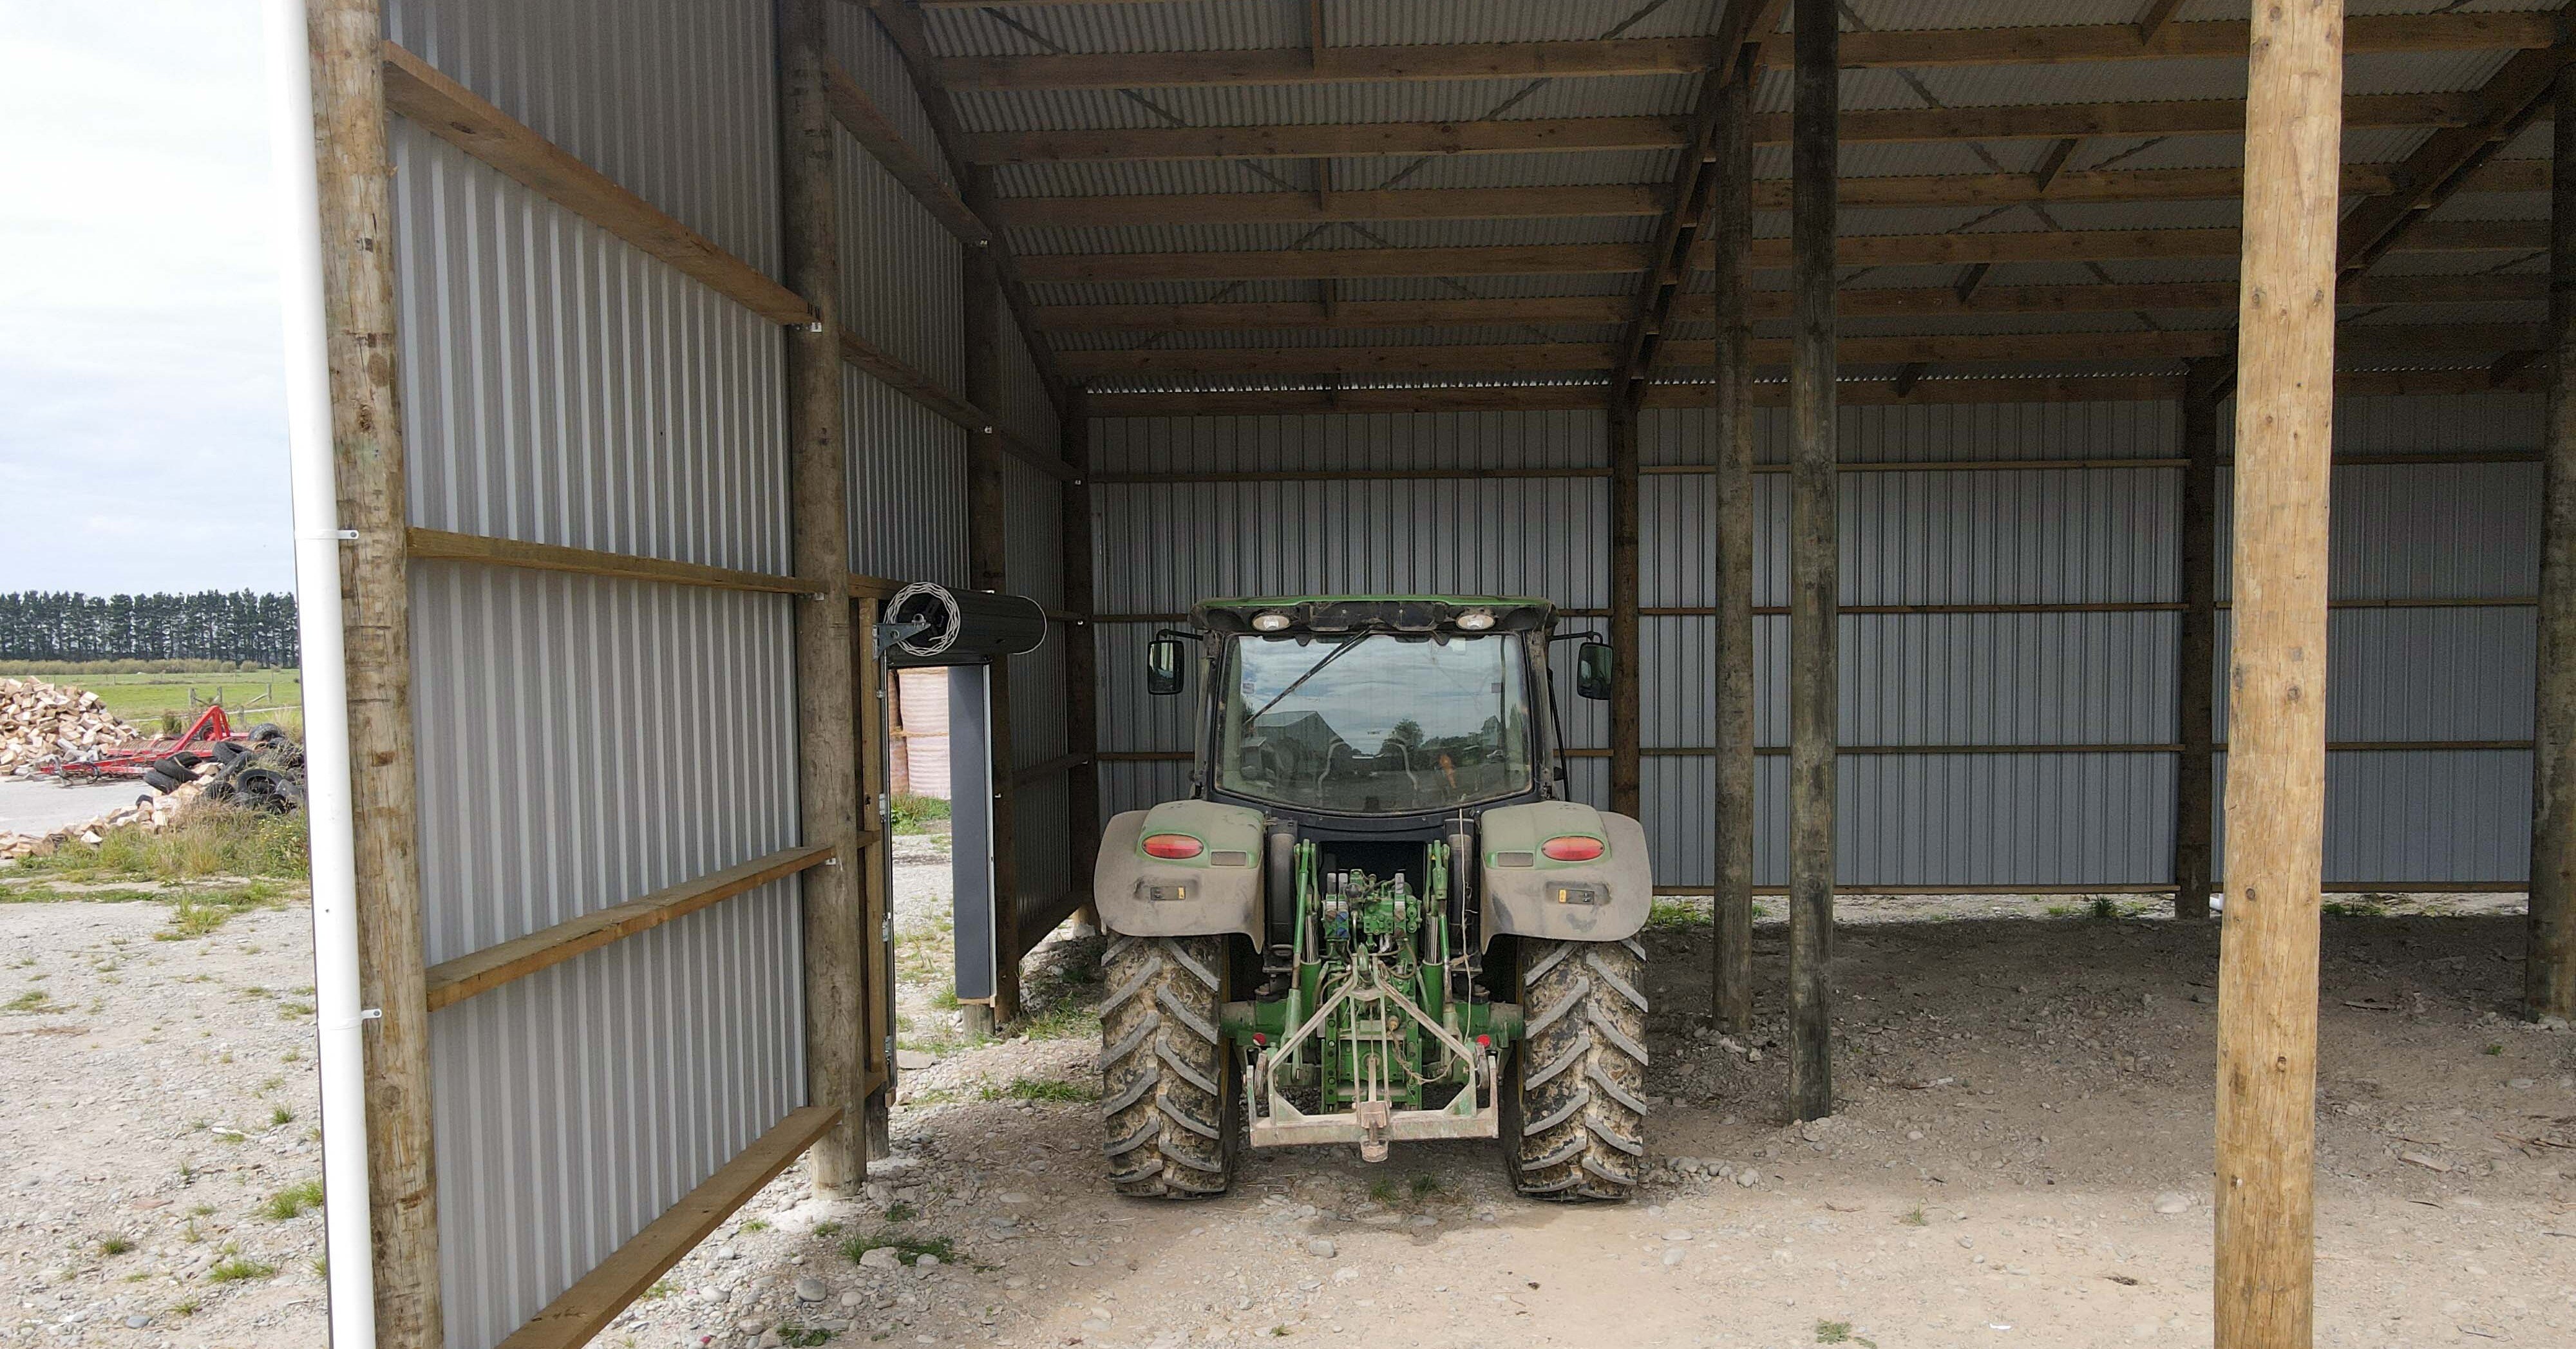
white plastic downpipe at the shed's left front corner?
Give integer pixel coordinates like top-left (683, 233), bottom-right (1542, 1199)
top-left (263, 0), bottom-right (376, 1349)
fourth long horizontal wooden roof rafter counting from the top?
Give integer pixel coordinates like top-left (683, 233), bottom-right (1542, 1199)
top-left (1023, 222), bottom-right (2548, 281)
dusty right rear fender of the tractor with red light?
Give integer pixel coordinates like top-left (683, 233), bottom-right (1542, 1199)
top-left (1476, 800), bottom-right (1654, 950)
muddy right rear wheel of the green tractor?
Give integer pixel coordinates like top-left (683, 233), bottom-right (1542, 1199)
top-left (1502, 937), bottom-right (1646, 1200)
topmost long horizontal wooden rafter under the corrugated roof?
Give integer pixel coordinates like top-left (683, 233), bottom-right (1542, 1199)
top-left (935, 13), bottom-right (2555, 93)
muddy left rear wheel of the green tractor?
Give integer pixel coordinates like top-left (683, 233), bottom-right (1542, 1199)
top-left (1100, 934), bottom-right (1242, 1200)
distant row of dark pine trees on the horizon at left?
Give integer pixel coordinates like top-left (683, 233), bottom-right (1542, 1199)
top-left (0, 590), bottom-right (296, 667)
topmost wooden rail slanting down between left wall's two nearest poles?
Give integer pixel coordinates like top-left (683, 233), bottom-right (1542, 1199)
top-left (384, 41), bottom-right (814, 325)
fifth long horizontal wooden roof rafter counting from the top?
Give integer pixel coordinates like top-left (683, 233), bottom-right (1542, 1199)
top-left (1038, 273), bottom-right (2548, 332)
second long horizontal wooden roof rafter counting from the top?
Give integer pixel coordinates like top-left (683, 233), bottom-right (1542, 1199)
top-left (956, 93), bottom-right (2478, 165)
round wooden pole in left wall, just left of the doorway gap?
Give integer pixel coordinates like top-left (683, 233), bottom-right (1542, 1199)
top-left (778, 0), bottom-right (868, 1192)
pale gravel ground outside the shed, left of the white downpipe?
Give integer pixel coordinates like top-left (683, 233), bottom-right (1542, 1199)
top-left (0, 901), bottom-right (322, 1349)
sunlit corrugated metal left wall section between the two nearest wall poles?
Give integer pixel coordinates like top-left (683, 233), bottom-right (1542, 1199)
top-left (386, 0), bottom-right (804, 1349)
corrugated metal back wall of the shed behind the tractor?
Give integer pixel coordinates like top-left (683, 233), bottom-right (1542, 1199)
top-left (1095, 397), bottom-right (2540, 885)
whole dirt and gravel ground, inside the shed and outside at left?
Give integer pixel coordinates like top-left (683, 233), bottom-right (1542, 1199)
top-left (0, 860), bottom-right (2576, 1349)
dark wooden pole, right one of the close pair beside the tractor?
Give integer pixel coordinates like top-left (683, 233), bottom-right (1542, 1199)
top-left (1788, 0), bottom-right (1842, 1120)
